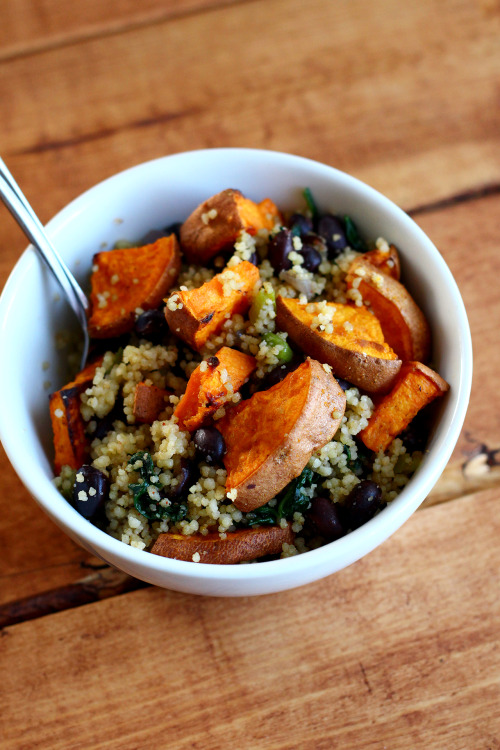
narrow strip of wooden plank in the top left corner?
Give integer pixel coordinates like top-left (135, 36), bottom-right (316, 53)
top-left (0, 0), bottom-right (247, 60)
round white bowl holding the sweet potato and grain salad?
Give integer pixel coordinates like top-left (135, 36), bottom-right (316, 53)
top-left (0, 149), bottom-right (472, 596)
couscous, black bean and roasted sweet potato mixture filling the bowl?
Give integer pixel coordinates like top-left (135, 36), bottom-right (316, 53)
top-left (51, 189), bottom-right (448, 563)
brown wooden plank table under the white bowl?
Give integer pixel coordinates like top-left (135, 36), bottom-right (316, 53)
top-left (0, 0), bottom-right (500, 750)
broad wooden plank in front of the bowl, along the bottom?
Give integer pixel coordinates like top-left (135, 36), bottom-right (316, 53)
top-left (0, 491), bottom-right (500, 750)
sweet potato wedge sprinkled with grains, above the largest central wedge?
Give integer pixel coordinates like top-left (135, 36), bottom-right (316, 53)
top-left (276, 296), bottom-right (401, 393)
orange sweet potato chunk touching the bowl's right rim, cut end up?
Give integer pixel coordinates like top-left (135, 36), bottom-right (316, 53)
top-left (359, 362), bottom-right (450, 452)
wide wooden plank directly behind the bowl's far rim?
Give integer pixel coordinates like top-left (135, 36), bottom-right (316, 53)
top-left (0, 0), bottom-right (500, 212)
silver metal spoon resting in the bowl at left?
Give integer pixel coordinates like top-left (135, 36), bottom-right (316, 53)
top-left (0, 157), bottom-right (89, 369)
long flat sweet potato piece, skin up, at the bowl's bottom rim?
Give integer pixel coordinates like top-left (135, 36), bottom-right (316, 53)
top-left (151, 524), bottom-right (295, 565)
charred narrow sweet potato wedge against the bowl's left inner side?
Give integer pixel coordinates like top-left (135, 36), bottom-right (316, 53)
top-left (49, 357), bottom-right (103, 475)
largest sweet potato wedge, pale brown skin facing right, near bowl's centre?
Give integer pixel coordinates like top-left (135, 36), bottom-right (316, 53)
top-left (217, 358), bottom-right (346, 511)
